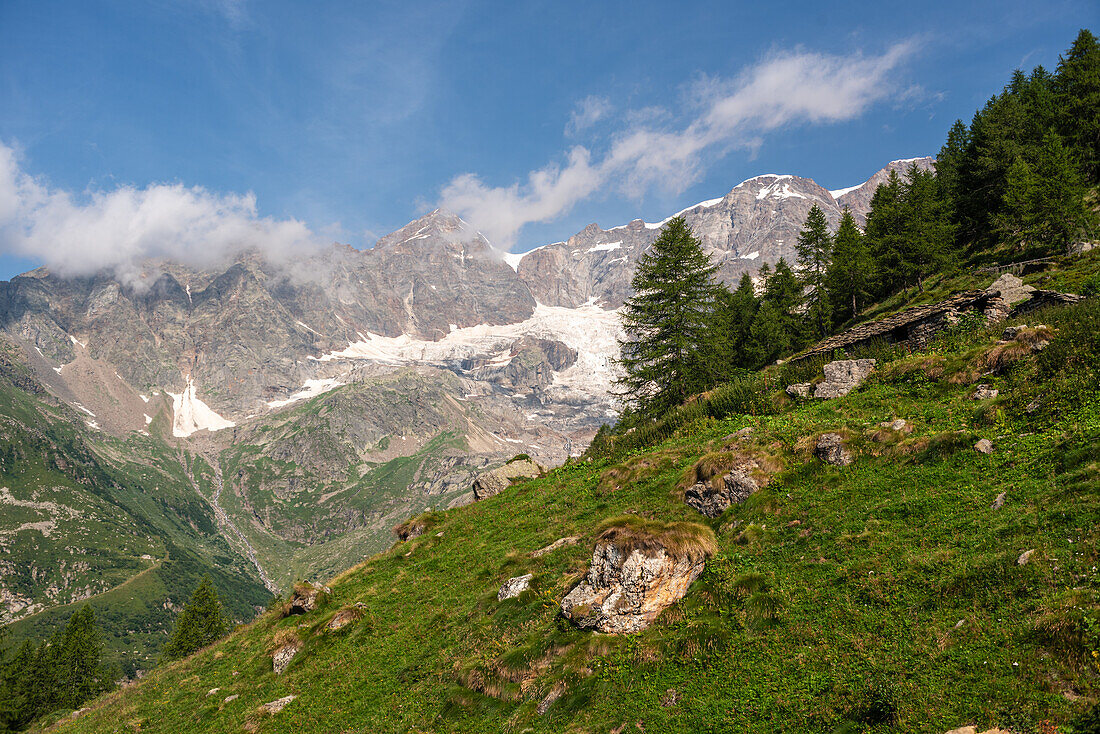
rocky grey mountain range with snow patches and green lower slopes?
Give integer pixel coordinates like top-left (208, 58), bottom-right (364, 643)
top-left (0, 157), bottom-right (933, 669)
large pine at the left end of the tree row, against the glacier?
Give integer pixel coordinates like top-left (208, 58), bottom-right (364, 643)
top-left (617, 217), bottom-right (718, 417)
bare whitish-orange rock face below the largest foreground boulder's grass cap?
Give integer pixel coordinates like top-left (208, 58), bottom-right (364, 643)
top-left (561, 541), bottom-right (706, 634)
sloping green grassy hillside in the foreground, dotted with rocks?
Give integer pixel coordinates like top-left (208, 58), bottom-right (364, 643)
top-left (51, 281), bottom-right (1100, 733)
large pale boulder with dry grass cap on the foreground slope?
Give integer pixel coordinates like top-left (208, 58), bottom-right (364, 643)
top-left (561, 518), bottom-right (714, 634)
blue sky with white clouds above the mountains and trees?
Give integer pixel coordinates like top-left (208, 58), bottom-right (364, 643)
top-left (0, 0), bottom-right (1098, 278)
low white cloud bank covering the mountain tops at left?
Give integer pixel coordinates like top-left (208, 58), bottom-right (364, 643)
top-left (0, 143), bottom-right (318, 285)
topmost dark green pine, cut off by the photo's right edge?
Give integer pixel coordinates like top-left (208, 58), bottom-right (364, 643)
top-left (1054, 30), bottom-right (1100, 184)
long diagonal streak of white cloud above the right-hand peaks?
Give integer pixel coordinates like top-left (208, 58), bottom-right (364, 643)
top-left (440, 42), bottom-right (914, 248)
